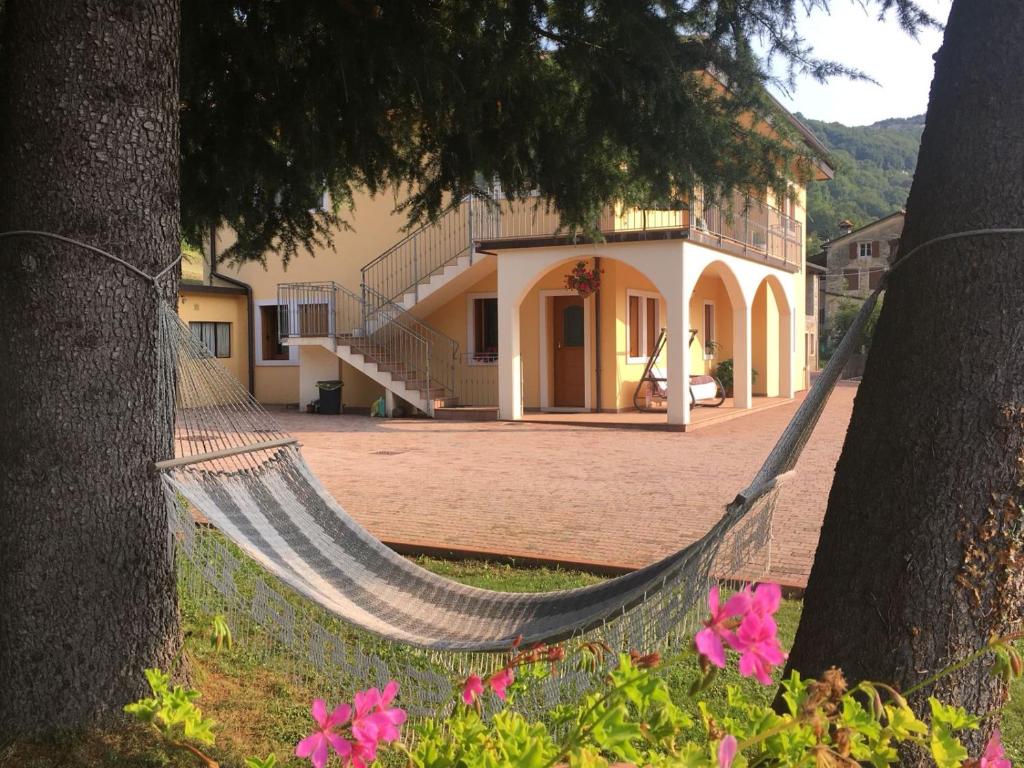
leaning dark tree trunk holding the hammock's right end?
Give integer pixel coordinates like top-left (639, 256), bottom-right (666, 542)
top-left (790, 0), bottom-right (1024, 755)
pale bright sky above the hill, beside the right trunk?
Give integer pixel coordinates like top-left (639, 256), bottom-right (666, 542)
top-left (773, 0), bottom-right (952, 125)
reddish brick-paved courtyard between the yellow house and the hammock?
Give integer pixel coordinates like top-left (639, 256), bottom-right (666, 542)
top-left (276, 384), bottom-right (856, 586)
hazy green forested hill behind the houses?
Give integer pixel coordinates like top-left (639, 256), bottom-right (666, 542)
top-left (798, 115), bottom-right (925, 253)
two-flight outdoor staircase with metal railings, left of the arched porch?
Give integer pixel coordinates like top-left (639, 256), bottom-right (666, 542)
top-left (278, 196), bottom-right (501, 419)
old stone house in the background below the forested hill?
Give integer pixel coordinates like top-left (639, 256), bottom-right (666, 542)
top-left (811, 211), bottom-right (906, 336)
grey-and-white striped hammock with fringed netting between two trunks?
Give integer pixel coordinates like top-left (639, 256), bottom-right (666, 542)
top-left (160, 295), bottom-right (877, 717)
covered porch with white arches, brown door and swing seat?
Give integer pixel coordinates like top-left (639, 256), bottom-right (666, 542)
top-left (492, 240), bottom-right (804, 429)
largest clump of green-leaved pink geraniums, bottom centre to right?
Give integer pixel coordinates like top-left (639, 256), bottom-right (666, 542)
top-left (408, 584), bottom-right (1022, 768)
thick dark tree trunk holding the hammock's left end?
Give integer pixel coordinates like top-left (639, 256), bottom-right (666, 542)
top-left (0, 0), bottom-right (180, 738)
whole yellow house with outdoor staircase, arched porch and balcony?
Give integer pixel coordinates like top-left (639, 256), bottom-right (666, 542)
top-left (188, 105), bottom-right (833, 425)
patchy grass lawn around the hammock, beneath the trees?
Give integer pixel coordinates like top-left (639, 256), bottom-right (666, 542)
top-left (0, 558), bottom-right (1024, 768)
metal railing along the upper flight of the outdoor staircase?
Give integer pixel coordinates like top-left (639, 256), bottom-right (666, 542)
top-left (362, 195), bottom-right (501, 301)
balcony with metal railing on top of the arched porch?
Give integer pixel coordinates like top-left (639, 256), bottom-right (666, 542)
top-left (479, 196), bottom-right (804, 271)
